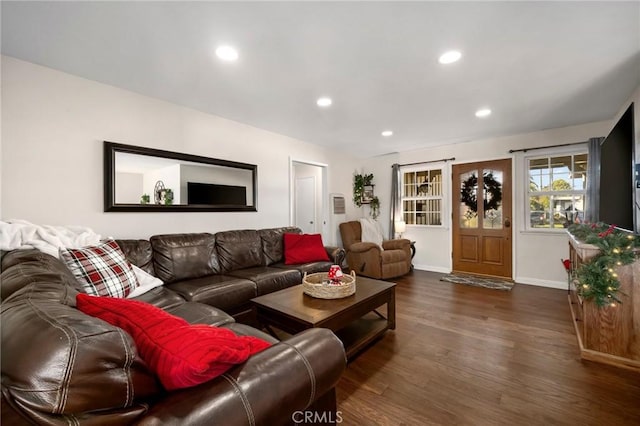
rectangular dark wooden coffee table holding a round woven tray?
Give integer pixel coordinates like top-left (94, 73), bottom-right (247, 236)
top-left (251, 277), bottom-right (396, 359)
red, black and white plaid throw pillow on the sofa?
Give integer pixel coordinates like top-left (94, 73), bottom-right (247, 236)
top-left (60, 240), bottom-right (138, 297)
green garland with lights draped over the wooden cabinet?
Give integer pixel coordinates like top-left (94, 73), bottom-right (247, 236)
top-left (568, 223), bottom-right (640, 306)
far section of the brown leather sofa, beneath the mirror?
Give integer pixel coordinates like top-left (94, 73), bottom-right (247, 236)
top-left (117, 227), bottom-right (345, 321)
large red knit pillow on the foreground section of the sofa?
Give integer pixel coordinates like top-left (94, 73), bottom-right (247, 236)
top-left (76, 293), bottom-right (270, 390)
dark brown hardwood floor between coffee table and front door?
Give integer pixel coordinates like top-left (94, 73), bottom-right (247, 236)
top-left (337, 271), bottom-right (640, 426)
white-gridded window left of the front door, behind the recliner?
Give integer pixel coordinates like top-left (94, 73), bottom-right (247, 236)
top-left (402, 169), bottom-right (444, 226)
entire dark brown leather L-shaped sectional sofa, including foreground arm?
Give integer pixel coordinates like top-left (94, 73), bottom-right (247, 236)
top-left (0, 228), bottom-right (346, 425)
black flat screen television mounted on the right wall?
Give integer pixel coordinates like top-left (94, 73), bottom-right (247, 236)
top-left (599, 104), bottom-right (637, 231)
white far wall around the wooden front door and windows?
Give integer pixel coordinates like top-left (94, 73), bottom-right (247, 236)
top-left (364, 121), bottom-right (611, 288)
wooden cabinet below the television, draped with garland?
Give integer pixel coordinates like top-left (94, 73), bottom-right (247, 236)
top-left (569, 234), bottom-right (640, 371)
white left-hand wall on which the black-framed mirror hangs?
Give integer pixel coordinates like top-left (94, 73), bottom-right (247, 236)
top-left (0, 56), bottom-right (356, 238)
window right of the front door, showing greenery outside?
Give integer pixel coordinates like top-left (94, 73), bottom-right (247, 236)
top-left (526, 153), bottom-right (587, 229)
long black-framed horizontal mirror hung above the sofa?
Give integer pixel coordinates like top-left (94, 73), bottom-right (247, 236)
top-left (104, 141), bottom-right (258, 212)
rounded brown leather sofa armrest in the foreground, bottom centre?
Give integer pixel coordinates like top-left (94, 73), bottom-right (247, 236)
top-left (139, 328), bottom-right (346, 425)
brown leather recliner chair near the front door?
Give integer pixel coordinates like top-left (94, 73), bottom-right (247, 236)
top-left (340, 220), bottom-right (411, 279)
